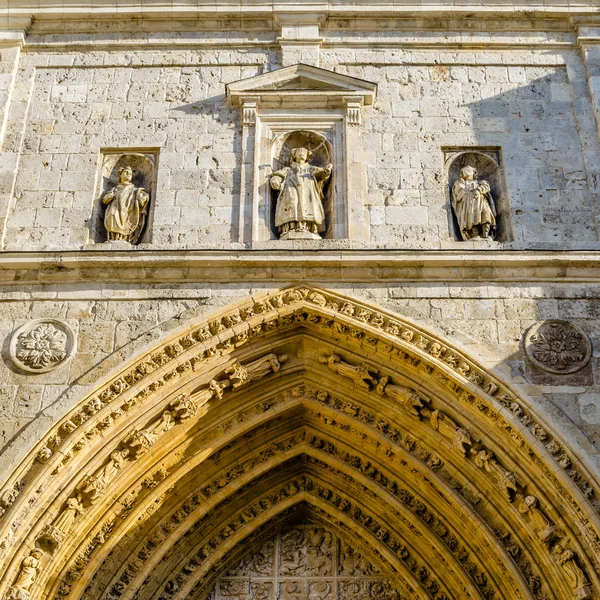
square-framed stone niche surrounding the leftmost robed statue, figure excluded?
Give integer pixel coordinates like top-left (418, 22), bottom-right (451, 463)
top-left (90, 148), bottom-right (158, 246)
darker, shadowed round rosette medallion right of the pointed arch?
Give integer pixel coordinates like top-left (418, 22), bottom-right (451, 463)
top-left (525, 320), bottom-right (592, 375)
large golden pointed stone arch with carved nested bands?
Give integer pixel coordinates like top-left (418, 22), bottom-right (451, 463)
top-left (0, 287), bottom-right (600, 600)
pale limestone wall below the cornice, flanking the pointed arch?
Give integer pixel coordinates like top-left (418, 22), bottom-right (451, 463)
top-left (0, 282), bottom-right (600, 482)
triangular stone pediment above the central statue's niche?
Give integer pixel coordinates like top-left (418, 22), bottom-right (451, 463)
top-left (227, 64), bottom-right (377, 106)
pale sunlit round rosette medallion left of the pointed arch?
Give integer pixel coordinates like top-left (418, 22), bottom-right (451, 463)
top-left (10, 319), bottom-right (76, 373)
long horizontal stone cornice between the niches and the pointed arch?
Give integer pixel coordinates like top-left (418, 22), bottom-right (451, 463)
top-left (0, 250), bottom-right (600, 287)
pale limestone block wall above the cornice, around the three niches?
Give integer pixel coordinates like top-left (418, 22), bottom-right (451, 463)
top-left (2, 21), bottom-right (600, 250)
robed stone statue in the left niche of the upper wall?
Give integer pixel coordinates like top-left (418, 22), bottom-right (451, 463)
top-left (102, 167), bottom-right (150, 244)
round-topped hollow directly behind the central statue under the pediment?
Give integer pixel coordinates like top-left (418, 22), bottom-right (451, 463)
top-left (267, 129), bottom-right (341, 239)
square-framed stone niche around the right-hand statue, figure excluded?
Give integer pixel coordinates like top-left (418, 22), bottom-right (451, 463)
top-left (442, 147), bottom-right (514, 242)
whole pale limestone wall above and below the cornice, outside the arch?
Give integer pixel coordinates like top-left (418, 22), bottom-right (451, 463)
top-left (0, 9), bottom-right (600, 508)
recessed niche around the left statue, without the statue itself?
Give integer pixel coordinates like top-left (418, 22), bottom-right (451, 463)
top-left (89, 150), bottom-right (158, 244)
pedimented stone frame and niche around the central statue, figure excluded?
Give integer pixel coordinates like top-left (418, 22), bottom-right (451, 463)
top-left (226, 64), bottom-right (377, 247)
